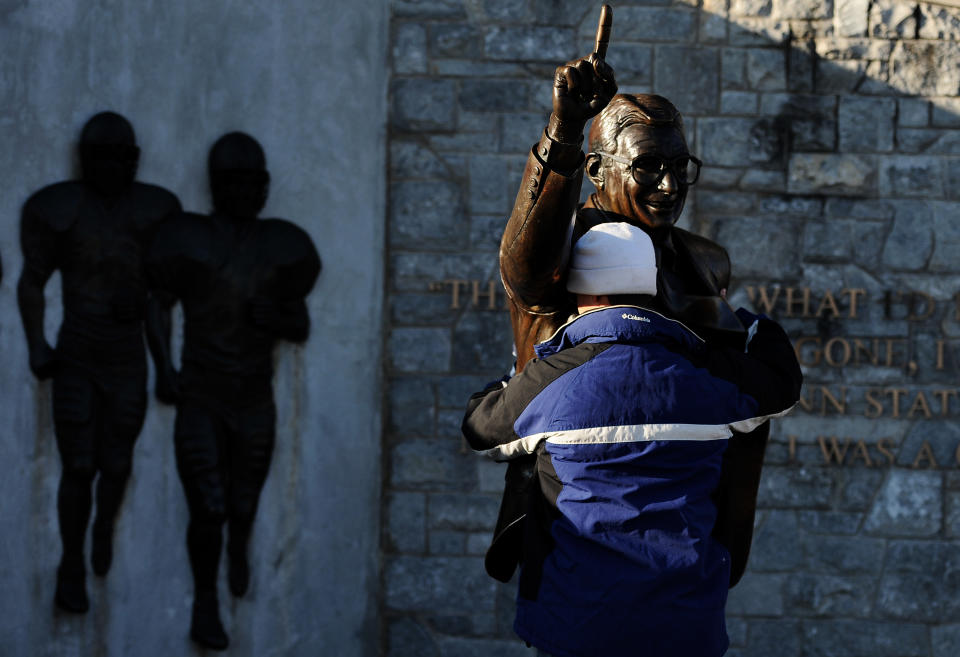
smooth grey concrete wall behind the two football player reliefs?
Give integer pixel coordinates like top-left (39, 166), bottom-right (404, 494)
top-left (0, 0), bottom-right (388, 657)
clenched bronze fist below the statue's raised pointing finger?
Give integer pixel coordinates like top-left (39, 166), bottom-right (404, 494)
top-left (547, 53), bottom-right (617, 143)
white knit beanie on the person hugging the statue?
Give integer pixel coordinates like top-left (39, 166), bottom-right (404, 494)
top-left (567, 222), bottom-right (657, 296)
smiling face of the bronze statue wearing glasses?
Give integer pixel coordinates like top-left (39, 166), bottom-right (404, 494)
top-left (597, 125), bottom-right (690, 228)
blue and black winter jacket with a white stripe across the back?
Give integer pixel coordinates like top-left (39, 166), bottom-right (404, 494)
top-left (463, 306), bottom-right (802, 657)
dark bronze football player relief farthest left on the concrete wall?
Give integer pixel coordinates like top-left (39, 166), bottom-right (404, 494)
top-left (17, 112), bottom-right (180, 612)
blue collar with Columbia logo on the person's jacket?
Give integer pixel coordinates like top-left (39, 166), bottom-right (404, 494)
top-left (533, 306), bottom-right (704, 358)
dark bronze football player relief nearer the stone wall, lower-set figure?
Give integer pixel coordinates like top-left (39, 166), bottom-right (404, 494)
top-left (147, 132), bottom-right (320, 650)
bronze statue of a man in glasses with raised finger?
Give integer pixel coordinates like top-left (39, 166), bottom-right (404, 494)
top-left (486, 11), bottom-right (768, 585)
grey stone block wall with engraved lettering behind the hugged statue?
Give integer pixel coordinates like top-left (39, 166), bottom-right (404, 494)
top-left (381, 0), bottom-right (960, 657)
